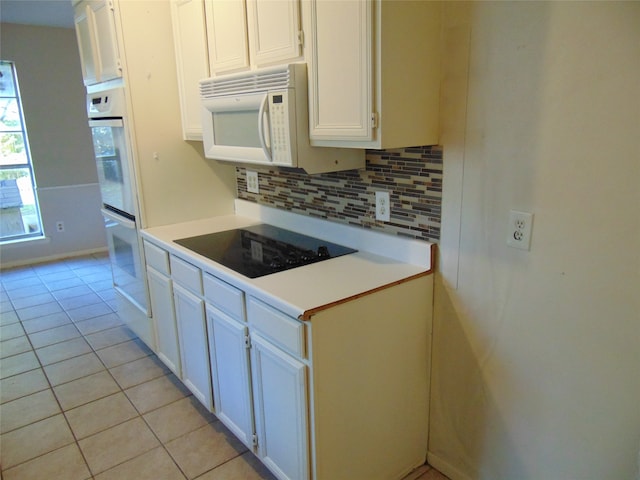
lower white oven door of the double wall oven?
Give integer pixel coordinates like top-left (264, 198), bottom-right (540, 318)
top-left (102, 209), bottom-right (149, 316)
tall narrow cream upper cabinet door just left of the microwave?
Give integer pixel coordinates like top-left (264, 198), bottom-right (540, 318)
top-left (171, 0), bottom-right (209, 140)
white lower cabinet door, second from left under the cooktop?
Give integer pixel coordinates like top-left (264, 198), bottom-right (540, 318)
top-left (173, 282), bottom-right (213, 410)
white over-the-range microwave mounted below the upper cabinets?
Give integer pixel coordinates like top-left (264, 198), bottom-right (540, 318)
top-left (200, 63), bottom-right (365, 173)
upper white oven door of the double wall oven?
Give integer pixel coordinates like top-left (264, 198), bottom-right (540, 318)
top-left (89, 119), bottom-right (136, 216)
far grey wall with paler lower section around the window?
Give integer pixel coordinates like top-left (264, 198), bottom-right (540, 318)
top-left (0, 23), bottom-right (106, 267)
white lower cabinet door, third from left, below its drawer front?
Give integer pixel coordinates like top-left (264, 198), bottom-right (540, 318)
top-left (207, 305), bottom-right (253, 448)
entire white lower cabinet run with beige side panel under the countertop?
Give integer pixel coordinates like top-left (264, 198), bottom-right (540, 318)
top-left (145, 237), bottom-right (433, 480)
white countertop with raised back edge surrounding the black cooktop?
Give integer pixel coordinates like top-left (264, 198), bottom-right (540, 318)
top-left (141, 201), bottom-right (432, 319)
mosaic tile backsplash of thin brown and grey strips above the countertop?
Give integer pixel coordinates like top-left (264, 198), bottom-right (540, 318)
top-left (236, 146), bottom-right (442, 242)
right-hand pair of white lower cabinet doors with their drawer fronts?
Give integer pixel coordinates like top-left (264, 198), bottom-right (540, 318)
top-left (204, 274), bottom-right (310, 480)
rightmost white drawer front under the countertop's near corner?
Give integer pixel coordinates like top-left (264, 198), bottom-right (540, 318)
top-left (247, 298), bottom-right (306, 357)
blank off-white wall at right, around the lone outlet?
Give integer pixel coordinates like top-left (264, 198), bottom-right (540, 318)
top-left (429, 2), bottom-right (640, 480)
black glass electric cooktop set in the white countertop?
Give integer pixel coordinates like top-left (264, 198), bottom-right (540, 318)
top-left (175, 224), bottom-right (357, 278)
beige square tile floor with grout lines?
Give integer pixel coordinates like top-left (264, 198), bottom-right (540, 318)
top-left (0, 255), bottom-right (446, 480)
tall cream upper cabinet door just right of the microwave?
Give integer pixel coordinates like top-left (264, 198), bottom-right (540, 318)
top-left (309, 0), bottom-right (374, 141)
